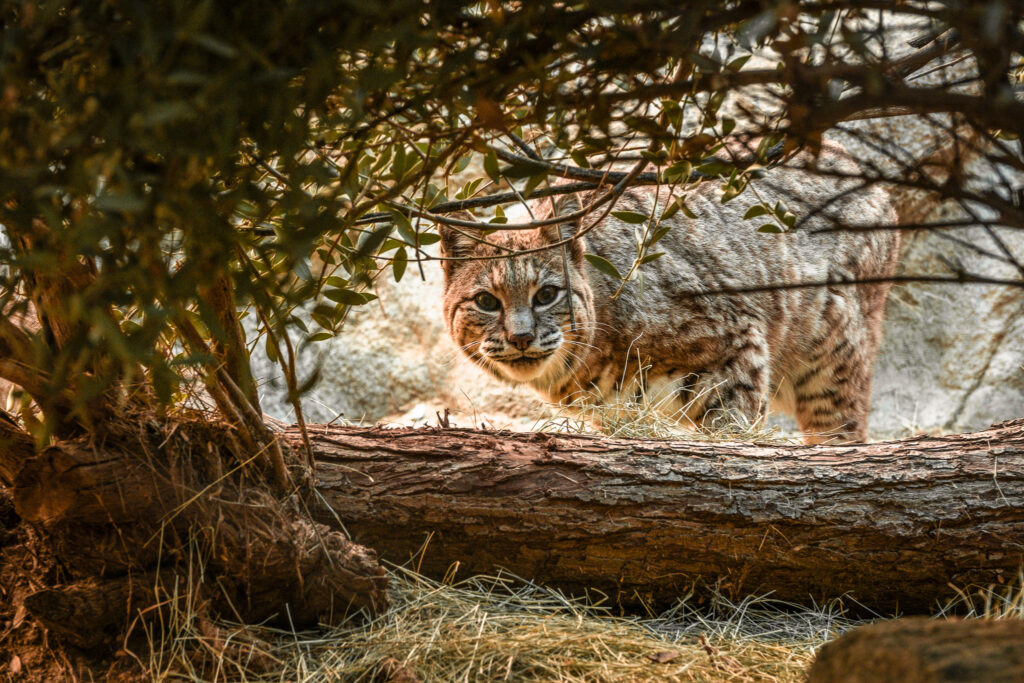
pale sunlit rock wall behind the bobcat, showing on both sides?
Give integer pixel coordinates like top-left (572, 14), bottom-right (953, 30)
top-left (254, 25), bottom-right (1024, 438)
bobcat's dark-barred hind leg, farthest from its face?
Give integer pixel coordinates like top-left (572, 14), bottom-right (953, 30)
top-left (791, 332), bottom-right (874, 443)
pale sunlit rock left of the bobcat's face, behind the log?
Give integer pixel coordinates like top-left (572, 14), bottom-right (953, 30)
top-left (253, 252), bottom-right (551, 429)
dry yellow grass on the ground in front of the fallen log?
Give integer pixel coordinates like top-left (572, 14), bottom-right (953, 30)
top-left (139, 569), bottom-right (868, 682)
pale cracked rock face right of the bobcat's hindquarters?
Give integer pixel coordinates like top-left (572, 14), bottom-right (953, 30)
top-left (871, 196), bottom-right (1024, 437)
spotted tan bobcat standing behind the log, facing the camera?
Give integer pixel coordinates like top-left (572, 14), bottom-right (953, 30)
top-left (440, 144), bottom-right (899, 443)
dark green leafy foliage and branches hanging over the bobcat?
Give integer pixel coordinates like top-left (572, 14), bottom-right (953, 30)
top-left (0, 0), bottom-right (1024, 433)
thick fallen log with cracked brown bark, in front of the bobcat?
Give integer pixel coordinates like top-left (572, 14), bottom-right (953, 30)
top-left (299, 421), bottom-right (1024, 613)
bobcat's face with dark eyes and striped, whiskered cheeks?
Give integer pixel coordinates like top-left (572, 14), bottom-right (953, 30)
top-left (441, 216), bottom-right (594, 390)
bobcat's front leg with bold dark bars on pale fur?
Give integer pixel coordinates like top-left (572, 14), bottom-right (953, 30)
top-left (683, 322), bottom-right (770, 430)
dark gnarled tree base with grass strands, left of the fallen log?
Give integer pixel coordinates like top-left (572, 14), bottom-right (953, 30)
top-left (0, 421), bottom-right (387, 647)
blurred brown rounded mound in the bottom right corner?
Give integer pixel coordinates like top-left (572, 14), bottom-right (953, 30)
top-left (810, 617), bottom-right (1024, 683)
